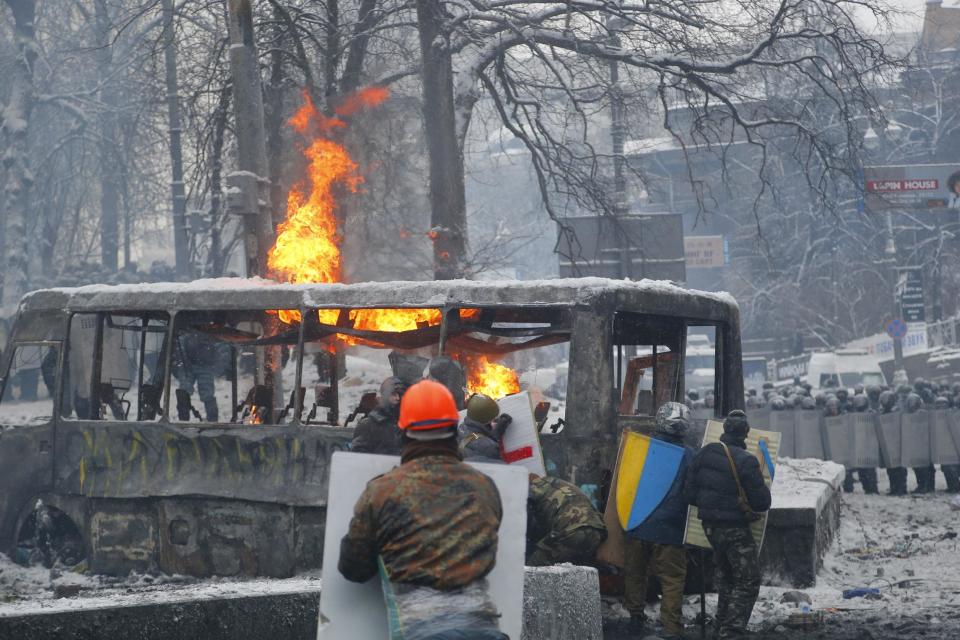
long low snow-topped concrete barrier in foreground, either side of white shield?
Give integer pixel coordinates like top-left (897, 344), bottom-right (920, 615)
top-left (0, 565), bottom-right (602, 640)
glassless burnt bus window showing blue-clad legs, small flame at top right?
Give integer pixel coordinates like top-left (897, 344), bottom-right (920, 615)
top-left (170, 310), bottom-right (303, 425)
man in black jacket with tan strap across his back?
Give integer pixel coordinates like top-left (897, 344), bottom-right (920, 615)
top-left (683, 410), bottom-right (770, 640)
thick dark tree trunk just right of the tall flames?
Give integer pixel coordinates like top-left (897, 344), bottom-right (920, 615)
top-left (417, 0), bottom-right (467, 280)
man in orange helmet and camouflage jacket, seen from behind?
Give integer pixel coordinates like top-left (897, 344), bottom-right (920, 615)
top-left (338, 380), bottom-right (507, 640)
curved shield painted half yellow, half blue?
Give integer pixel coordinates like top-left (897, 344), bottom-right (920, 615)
top-left (616, 431), bottom-right (683, 531)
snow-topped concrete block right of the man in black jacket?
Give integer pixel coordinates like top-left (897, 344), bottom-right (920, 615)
top-left (760, 458), bottom-right (844, 589)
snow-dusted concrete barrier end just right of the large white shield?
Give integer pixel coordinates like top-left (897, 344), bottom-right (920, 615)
top-left (521, 564), bottom-right (603, 640)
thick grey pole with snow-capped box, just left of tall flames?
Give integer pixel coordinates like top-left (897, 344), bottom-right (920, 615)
top-left (227, 0), bottom-right (274, 277)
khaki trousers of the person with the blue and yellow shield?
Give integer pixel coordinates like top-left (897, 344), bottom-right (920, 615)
top-left (623, 540), bottom-right (687, 636)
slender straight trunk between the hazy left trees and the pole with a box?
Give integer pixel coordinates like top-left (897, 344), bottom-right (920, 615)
top-left (162, 0), bottom-right (191, 280)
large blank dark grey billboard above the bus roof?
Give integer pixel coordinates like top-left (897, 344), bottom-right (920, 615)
top-left (557, 213), bottom-right (687, 282)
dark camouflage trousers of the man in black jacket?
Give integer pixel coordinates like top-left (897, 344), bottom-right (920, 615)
top-left (704, 526), bottom-right (760, 640)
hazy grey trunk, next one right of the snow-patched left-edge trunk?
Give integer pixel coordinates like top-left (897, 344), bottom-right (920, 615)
top-left (94, 0), bottom-right (120, 273)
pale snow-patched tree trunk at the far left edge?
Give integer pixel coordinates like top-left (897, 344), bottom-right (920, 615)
top-left (0, 0), bottom-right (37, 310)
